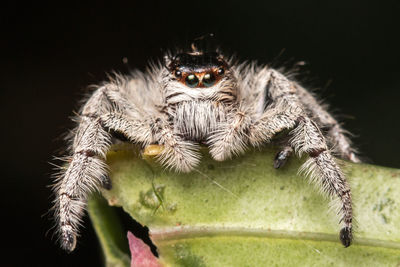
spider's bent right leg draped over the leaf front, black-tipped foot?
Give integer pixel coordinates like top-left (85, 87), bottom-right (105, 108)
top-left (244, 70), bottom-right (353, 247)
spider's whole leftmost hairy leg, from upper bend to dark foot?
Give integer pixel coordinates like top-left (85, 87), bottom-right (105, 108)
top-left (54, 84), bottom-right (153, 251)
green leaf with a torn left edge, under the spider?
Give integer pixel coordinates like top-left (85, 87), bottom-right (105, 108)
top-left (89, 147), bottom-right (400, 266)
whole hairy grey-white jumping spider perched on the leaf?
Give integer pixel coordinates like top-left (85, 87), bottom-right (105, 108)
top-left (54, 40), bottom-right (359, 251)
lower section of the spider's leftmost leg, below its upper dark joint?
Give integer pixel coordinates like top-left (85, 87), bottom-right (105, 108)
top-left (56, 119), bottom-right (110, 251)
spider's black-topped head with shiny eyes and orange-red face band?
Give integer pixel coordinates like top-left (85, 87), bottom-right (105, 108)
top-left (168, 51), bottom-right (228, 88)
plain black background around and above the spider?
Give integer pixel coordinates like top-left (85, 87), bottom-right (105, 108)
top-left (0, 1), bottom-right (400, 266)
